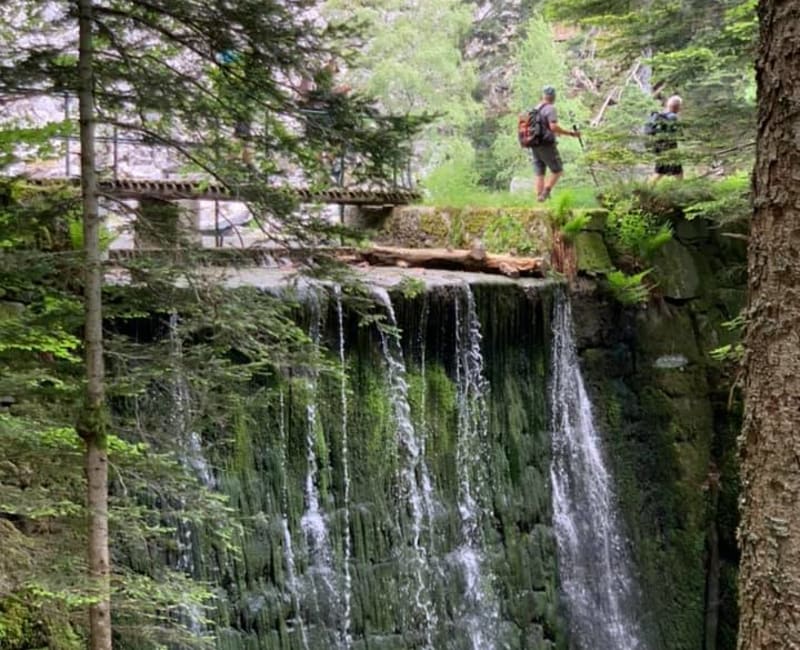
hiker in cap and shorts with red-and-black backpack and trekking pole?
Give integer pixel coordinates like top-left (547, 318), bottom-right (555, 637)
top-left (518, 86), bottom-right (580, 202)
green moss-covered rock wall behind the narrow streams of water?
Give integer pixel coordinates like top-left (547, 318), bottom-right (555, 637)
top-left (198, 283), bottom-right (565, 650)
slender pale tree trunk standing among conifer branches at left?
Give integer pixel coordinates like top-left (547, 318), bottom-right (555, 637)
top-left (77, 0), bottom-right (111, 650)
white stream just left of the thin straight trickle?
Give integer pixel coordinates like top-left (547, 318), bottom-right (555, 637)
top-left (300, 290), bottom-right (341, 647)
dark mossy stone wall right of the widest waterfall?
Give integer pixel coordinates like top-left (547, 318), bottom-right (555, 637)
top-left (366, 204), bottom-right (746, 650)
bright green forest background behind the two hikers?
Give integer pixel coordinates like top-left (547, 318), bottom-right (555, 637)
top-left (325, 0), bottom-right (756, 203)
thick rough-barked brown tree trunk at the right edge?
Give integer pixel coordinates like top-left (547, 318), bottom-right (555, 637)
top-left (738, 0), bottom-right (800, 650)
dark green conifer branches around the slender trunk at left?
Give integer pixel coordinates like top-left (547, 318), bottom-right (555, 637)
top-left (0, 0), bottom-right (414, 650)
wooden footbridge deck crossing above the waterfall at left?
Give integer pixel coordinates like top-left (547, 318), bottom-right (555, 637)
top-left (22, 177), bottom-right (421, 206)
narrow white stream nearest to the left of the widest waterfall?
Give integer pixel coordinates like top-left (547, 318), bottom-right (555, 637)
top-left (454, 285), bottom-right (499, 650)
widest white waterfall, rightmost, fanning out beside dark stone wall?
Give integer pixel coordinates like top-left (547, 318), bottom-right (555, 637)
top-left (550, 295), bottom-right (645, 650)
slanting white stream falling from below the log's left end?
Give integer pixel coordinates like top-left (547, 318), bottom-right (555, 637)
top-left (375, 289), bottom-right (437, 650)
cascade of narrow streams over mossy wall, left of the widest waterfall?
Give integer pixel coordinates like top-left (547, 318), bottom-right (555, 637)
top-left (126, 283), bottom-right (562, 650)
